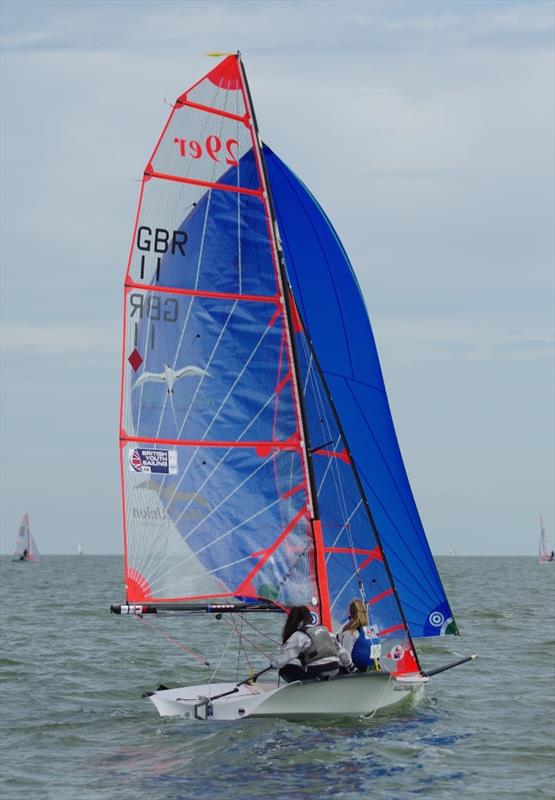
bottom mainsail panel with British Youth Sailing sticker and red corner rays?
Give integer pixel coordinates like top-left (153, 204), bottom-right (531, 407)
top-left (122, 441), bottom-right (312, 601)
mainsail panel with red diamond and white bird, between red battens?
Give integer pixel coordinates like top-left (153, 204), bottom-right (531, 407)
top-left (123, 288), bottom-right (297, 443)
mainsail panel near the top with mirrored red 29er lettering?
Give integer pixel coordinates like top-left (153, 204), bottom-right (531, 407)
top-left (147, 106), bottom-right (260, 190)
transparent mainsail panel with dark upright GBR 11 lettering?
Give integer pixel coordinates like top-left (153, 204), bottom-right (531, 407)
top-left (129, 178), bottom-right (277, 296)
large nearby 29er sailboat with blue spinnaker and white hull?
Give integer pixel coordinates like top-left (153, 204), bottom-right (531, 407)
top-left (111, 53), bottom-right (474, 720)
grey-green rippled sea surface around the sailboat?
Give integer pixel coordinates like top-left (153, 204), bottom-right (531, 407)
top-left (0, 556), bottom-right (555, 800)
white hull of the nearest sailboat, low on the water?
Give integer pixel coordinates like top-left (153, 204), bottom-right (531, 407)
top-left (150, 672), bottom-right (429, 720)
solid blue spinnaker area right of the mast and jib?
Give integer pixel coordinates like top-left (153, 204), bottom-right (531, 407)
top-left (265, 148), bottom-right (457, 637)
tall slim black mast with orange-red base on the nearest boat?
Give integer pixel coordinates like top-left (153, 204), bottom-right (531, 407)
top-left (237, 52), bottom-right (332, 629)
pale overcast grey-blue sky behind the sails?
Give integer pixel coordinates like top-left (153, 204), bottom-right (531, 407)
top-left (0, 0), bottom-right (555, 555)
